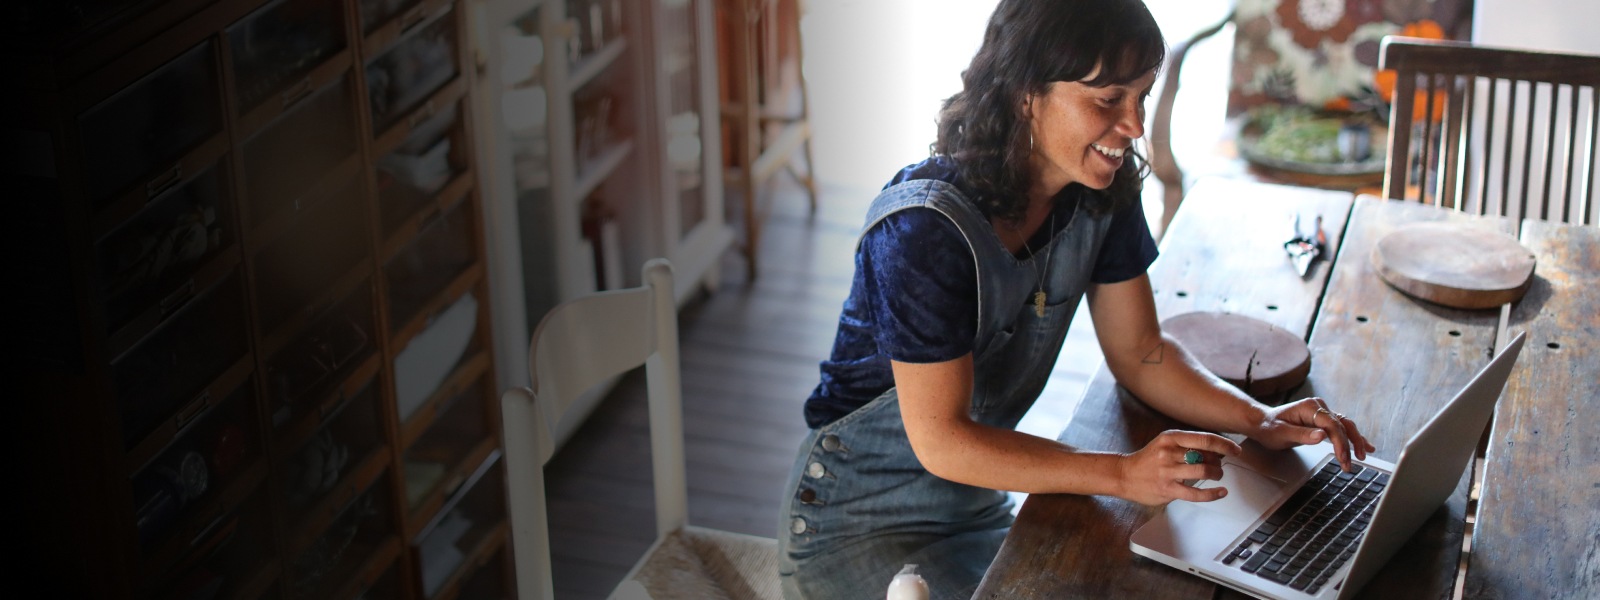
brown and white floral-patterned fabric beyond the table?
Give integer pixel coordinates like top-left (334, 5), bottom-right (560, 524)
top-left (1227, 0), bottom-right (1472, 115)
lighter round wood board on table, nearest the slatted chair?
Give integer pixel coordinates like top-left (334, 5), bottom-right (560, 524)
top-left (1373, 222), bottom-right (1534, 309)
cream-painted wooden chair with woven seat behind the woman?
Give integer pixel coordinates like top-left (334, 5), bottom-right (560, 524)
top-left (501, 259), bottom-right (779, 600)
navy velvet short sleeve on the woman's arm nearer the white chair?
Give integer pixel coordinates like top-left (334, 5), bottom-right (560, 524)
top-left (861, 208), bottom-right (978, 363)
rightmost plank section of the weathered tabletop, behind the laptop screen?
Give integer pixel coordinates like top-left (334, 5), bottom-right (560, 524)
top-left (1466, 221), bottom-right (1600, 598)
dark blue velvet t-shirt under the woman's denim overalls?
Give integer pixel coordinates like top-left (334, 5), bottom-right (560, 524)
top-left (805, 157), bottom-right (1157, 429)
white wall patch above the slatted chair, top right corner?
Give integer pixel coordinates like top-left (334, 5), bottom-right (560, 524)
top-left (1472, 0), bottom-right (1600, 54)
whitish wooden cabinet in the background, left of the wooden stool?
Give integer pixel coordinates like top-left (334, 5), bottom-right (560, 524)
top-left (469, 0), bottom-right (733, 438)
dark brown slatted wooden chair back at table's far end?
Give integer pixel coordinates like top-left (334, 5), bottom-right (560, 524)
top-left (1381, 37), bottom-right (1600, 224)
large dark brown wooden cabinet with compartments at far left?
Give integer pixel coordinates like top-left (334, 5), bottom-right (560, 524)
top-left (0, 0), bottom-right (512, 598)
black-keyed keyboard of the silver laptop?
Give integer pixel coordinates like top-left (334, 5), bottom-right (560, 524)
top-left (1222, 462), bottom-right (1389, 594)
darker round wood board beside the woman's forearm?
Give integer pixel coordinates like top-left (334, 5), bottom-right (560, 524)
top-left (1162, 312), bottom-right (1310, 397)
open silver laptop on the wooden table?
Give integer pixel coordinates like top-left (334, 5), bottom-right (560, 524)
top-left (1128, 333), bottom-right (1525, 600)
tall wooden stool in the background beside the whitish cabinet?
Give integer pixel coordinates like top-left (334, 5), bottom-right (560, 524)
top-left (717, 0), bottom-right (816, 280)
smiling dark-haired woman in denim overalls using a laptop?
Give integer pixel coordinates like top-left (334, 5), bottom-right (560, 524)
top-left (779, 0), bottom-right (1373, 598)
